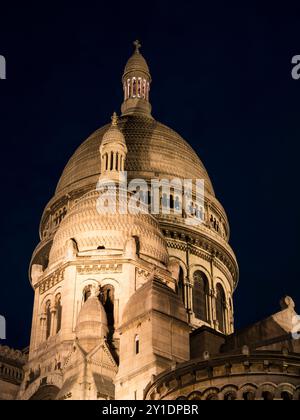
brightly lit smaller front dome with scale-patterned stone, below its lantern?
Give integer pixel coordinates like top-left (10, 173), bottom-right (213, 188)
top-left (49, 190), bottom-right (168, 265)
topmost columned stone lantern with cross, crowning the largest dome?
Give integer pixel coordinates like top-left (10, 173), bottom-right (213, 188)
top-left (121, 41), bottom-right (151, 117)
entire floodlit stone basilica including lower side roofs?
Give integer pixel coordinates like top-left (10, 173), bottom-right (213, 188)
top-left (0, 41), bottom-right (300, 400)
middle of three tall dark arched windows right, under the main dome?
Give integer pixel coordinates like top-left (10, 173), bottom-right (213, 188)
top-left (193, 270), bottom-right (208, 322)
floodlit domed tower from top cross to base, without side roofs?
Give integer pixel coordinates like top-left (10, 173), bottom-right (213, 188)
top-left (19, 42), bottom-right (238, 399)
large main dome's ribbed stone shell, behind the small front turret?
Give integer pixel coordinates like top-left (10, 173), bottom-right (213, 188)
top-left (56, 115), bottom-right (214, 195)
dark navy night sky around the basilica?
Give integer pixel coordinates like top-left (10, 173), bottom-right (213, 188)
top-left (0, 0), bottom-right (300, 348)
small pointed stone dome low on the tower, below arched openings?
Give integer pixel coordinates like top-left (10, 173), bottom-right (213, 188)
top-left (76, 294), bottom-right (108, 352)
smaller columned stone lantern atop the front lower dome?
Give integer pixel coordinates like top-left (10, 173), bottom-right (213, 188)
top-left (100, 112), bottom-right (127, 181)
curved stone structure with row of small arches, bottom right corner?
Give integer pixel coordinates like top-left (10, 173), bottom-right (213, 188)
top-left (144, 352), bottom-right (300, 400)
